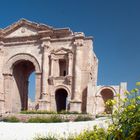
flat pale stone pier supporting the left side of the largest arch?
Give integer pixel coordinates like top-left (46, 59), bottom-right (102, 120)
top-left (4, 74), bottom-right (12, 113)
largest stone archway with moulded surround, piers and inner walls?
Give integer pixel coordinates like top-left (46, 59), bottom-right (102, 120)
top-left (3, 54), bottom-right (41, 112)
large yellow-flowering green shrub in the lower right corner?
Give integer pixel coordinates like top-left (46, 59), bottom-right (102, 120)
top-left (107, 82), bottom-right (140, 140)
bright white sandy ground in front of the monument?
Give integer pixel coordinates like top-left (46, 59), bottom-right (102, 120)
top-left (0, 119), bottom-right (107, 140)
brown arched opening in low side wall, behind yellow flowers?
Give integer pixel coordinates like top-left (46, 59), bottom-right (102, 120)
top-left (100, 88), bottom-right (114, 114)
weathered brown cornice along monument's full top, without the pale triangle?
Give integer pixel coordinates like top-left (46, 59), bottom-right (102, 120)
top-left (0, 19), bottom-right (91, 45)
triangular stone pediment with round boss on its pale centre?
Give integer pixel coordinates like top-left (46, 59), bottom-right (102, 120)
top-left (3, 19), bottom-right (52, 38)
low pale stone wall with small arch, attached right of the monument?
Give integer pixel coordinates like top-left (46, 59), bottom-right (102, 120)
top-left (87, 83), bottom-right (127, 114)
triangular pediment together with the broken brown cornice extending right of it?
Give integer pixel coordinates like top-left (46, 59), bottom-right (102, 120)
top-left (0, 19), bottom-right (73, 45)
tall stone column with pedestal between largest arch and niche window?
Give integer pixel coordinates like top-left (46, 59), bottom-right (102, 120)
top-left (39, 40), bottom-right (50, 111)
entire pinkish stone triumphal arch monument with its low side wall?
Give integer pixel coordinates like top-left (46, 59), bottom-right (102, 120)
top-left (0, 19), bottom-right (126, 114)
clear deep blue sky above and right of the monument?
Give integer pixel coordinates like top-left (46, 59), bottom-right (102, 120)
top-left (0, 0), bottom-right (140, 99)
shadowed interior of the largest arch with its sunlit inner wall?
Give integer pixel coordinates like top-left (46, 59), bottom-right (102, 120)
top-left (12, 60), bottom-right (35, 112)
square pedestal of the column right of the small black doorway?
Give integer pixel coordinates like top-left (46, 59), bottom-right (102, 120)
top-left (70, 100), bottom-right (82, 113)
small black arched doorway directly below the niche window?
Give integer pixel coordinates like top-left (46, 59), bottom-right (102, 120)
top-left (55, 89), bottom-right (68, 112)
